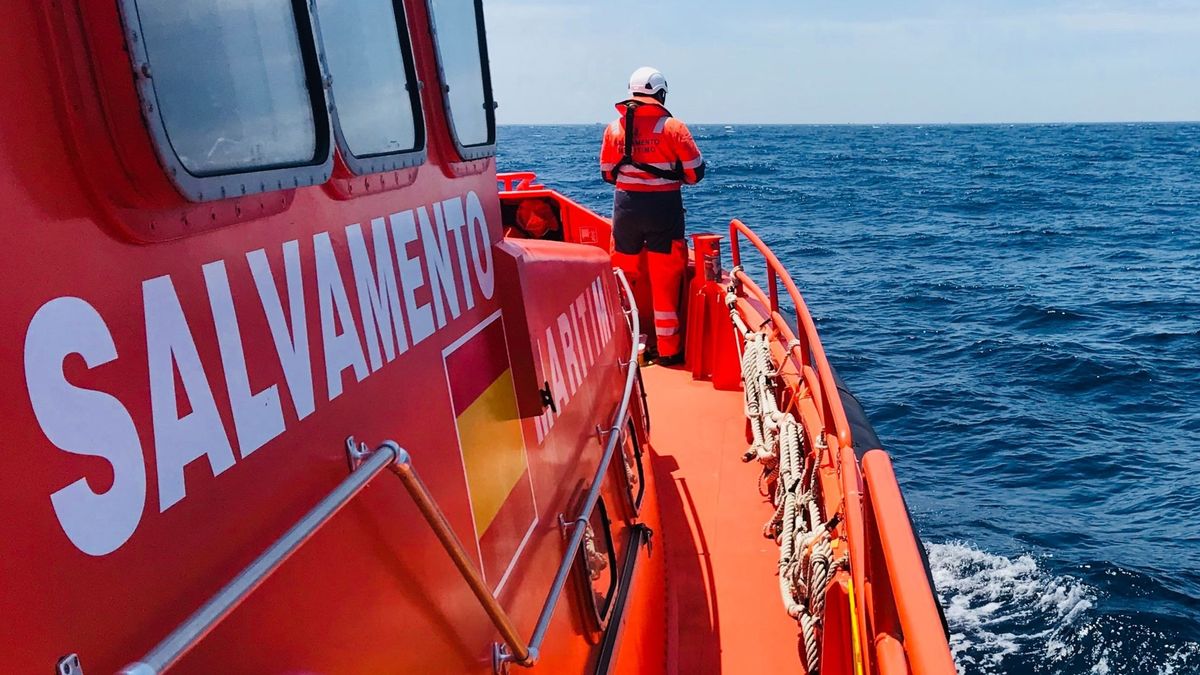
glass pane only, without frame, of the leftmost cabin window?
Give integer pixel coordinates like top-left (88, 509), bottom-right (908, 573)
top-left (138, 0), bottom-right (317, 175)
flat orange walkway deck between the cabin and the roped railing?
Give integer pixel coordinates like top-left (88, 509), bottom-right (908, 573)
top-left (643, 366), bottom-right (802, 674)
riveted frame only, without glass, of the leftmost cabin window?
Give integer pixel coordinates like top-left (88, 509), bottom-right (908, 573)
top-left (116, 0), bottom-right (334, 203)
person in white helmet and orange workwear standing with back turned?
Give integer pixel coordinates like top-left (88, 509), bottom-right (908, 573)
top-left (600, 66), bottom-right (704, 365)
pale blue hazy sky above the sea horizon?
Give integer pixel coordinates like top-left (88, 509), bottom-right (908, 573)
top-left (484, 0), bottom-right (1200, 124)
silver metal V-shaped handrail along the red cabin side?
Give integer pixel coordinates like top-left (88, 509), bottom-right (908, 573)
top-left (121, 269), bottom-right (641, 675)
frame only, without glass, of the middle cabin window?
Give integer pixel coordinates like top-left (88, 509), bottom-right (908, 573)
top-left (312, 0), bottom-right (428, 177)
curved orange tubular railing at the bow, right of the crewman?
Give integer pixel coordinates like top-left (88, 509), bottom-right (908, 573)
top-left (730, 219), bottom-right (851, 447)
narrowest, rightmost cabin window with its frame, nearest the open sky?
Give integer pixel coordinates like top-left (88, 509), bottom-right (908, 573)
top-left (430, 0), bottom-right (496, 160)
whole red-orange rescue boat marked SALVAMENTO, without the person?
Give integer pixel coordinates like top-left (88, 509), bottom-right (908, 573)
top-left (0, 0), bottom-right (955, 675)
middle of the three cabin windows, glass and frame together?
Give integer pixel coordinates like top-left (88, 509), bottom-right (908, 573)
top-left (317, 0), bottom-right (425, 168)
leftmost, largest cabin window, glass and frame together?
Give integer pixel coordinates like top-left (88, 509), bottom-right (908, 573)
top-left (118, 0), bottom-right (332, 202)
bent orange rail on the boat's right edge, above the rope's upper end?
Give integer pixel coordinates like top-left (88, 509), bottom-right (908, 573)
top-left (730, 219), bottom-right (852, 446)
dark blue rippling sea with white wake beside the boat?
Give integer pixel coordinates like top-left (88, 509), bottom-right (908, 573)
top-left (499, 124), bottom-right (1200, 675)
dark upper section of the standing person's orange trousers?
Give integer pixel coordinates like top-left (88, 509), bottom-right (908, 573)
top-left (612, 190), bottom-right (684, 255)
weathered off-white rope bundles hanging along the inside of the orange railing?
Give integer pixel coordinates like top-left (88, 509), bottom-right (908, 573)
top-left (725, 286), bottom-right (847, 674)
